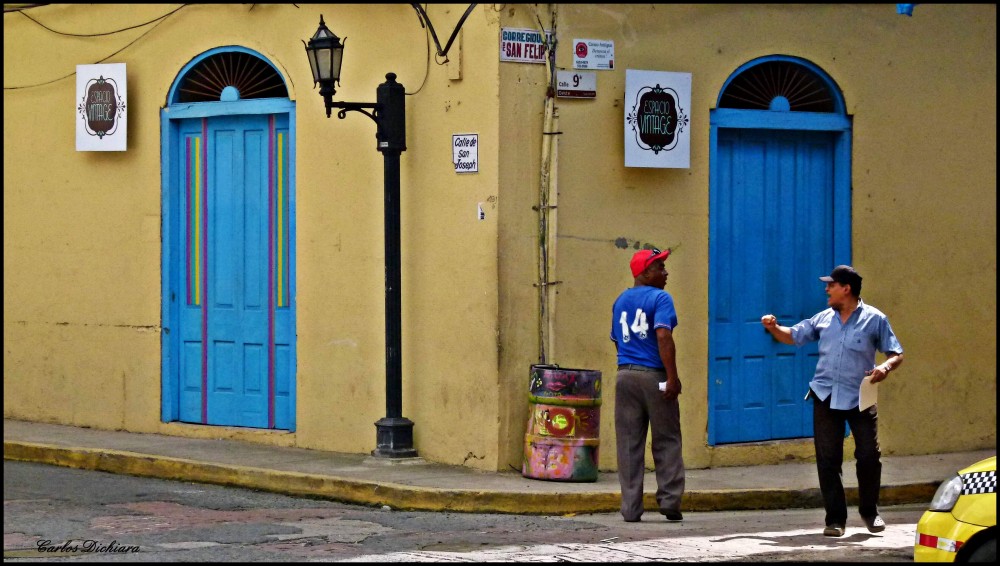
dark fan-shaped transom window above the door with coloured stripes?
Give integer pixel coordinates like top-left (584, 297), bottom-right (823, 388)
top-left (176, 51), bottom-right (288, 102)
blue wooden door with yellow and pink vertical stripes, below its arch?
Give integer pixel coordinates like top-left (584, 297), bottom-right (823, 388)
top-left (172, 114), bottom-right (294, 429)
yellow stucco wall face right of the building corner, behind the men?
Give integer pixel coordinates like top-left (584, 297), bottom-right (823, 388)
top-left (500, 4), bottom-right (996, 469)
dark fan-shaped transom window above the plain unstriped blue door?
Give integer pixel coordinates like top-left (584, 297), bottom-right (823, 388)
top-left (719, 60), bottom-right (837, 112)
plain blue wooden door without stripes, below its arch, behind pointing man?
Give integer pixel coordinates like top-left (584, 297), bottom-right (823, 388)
top-left (709, 128), bottom-right (835, 443)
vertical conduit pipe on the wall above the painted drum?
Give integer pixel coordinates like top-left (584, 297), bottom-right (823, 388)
top-left (532, 5), bottom-right (562, 364)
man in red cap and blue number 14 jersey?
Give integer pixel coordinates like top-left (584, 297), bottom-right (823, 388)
top-left (611, 249), bottom-right (684, 522)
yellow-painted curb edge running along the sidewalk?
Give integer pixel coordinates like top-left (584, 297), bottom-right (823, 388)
top-left (3, 440), bottom-right (938, 515)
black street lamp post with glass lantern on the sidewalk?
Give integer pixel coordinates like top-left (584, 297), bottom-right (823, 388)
top-left (303, 15), bottom-right (417, 458)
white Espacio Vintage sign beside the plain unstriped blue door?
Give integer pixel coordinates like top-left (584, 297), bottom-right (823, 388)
top-left (625, 69), bottom-right (691, 169)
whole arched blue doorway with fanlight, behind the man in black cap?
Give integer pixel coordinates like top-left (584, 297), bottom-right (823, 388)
top-left (708, 56), bottom-right (850, 445)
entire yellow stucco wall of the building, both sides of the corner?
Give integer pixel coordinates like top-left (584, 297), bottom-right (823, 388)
top-left (4, 4), bottom-right (996, 470)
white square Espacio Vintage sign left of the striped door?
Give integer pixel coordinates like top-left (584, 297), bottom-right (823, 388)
top-left (75, 63), bottom-right (128, 151)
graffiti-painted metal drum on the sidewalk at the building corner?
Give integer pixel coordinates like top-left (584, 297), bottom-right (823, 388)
top-left (521, 365), bottom-right (601, 482)
